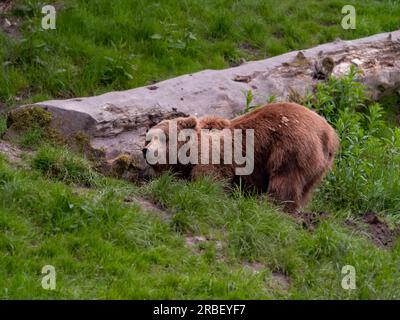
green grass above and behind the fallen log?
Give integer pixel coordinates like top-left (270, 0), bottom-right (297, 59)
top-left (0, 0), bottom-right (400, 107)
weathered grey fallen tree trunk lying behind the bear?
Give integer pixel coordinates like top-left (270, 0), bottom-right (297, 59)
top-left (5, 31), bottom-right (400, 178)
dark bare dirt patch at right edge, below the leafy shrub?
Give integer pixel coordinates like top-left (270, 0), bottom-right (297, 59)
top-left (346, 212), bottom-right (400, 249)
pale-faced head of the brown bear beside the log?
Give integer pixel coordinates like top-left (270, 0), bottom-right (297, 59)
top-left (142, 117), bottom-right (199, 175)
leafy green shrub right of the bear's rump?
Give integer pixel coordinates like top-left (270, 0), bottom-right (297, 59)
top-left (305, 69), bottom-right (400, 213)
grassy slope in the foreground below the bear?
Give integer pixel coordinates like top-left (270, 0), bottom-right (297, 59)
top-left (0, 147), bottom-right (400, 299)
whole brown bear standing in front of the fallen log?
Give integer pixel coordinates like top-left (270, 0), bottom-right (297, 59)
top-left (143, 103), bottom-right (339, 211)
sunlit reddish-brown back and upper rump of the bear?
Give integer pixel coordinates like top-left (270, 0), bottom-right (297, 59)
top-left (231, 103), bottom-right (339, 170)
